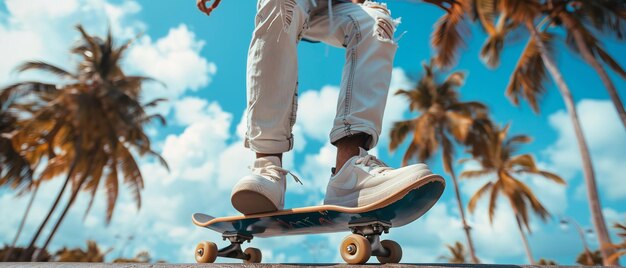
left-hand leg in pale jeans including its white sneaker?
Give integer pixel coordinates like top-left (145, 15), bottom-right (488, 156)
top-left (231, 0), bottom-right (310, 214)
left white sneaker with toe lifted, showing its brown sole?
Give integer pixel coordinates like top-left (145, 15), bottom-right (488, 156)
top-left (230, 156), bottom-right (302, 214)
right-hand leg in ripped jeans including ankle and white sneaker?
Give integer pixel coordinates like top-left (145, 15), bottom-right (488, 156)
top-left (305, 1), bottom-right (432, 207)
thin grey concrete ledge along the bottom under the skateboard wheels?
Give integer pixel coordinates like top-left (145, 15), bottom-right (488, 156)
top-left (0, 262), bottom-right (604, 268)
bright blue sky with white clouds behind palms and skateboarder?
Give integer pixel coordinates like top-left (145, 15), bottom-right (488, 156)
top-left (0, 0), bottom-right (626, 264)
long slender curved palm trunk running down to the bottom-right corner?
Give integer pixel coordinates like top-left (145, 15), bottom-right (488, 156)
top-left (526, 22), bottom-right (618, 265)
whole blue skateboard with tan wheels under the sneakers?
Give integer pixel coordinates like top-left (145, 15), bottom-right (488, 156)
top-left (192, 174), bottom-right (445, 264)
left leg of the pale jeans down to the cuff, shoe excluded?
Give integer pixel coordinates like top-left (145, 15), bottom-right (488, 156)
top-left (245, 0), bottom-right (310, 157)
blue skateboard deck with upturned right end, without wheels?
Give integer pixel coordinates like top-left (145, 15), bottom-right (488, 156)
top-left (192, 175), bottom-right (445, 237)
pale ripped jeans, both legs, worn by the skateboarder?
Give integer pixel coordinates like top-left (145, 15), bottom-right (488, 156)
top-left (245, 0), bottom-right (398, 154)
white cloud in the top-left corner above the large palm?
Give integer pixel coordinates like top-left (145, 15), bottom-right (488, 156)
top-left (0, 0), bottom-right (145, 83)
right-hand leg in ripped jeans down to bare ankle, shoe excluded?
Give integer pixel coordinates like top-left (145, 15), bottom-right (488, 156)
top-left (305, 1), bottom-right (397, 170)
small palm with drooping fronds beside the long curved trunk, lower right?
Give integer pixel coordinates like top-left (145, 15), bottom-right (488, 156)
top-left (461, 125), bottom-right (565, 264)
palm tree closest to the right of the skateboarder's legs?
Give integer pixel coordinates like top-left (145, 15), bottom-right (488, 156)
top-left (389, 62), bottom-right (489, 263)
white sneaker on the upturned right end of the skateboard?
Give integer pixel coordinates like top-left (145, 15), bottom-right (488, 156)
top-left (324, 149), bottom-right (432, 207)
